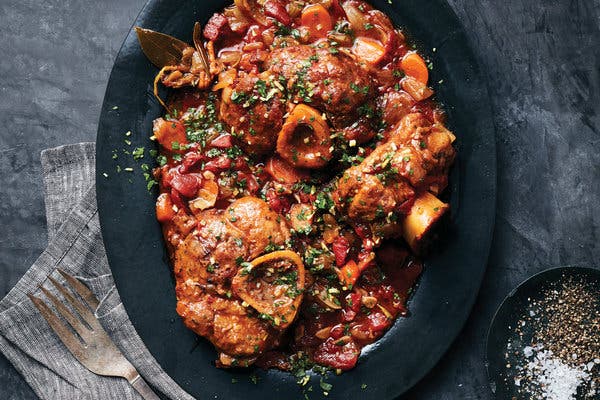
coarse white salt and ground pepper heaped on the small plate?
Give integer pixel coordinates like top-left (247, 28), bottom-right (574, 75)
top-left (505, 276), bottom-right (600, 400)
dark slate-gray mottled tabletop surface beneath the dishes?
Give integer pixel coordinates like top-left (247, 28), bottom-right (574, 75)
top-left (0, 0), bottom-right (600, 400)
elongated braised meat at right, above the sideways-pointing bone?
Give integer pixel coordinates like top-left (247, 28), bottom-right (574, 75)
top-left (333, 113), bottom-right (454, 222)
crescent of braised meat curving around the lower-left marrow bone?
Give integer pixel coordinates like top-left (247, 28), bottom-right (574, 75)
top-left (173, 197), bottom-right (289, 364)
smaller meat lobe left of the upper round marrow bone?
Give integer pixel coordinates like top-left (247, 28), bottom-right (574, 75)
top-left (220, 72), bottom-right (286, 155)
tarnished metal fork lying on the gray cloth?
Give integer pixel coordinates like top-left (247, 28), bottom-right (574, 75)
top-left (27, 269), bottom-right (159, 400)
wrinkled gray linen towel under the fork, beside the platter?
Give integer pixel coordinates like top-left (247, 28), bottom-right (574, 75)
top-left (0, 143), bottom-right (192, 400)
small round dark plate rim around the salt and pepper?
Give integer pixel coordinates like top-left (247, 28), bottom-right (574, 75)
top-left (486, 267), bottom-right (600, 400)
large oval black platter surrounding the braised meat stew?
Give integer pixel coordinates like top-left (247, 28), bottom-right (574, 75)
top-left (96, 0), bottom-right (496, 400)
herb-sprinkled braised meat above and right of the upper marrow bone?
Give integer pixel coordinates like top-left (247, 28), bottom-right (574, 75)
top-left (266, 45), bottom-right (375, 143)
